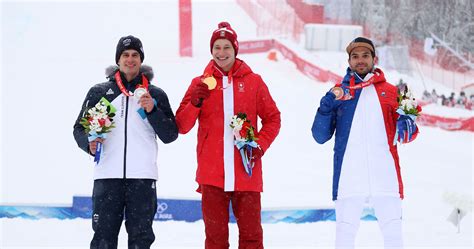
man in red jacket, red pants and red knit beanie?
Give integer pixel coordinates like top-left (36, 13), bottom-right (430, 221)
top-left (176, 22), bottom-right (280, 249)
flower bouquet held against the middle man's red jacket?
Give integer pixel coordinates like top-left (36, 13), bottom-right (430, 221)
top-left (230, 112), bottom-right (258, 176)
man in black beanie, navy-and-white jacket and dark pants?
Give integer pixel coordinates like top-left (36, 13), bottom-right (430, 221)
top-left (74, 36), bottom-right (178, 249)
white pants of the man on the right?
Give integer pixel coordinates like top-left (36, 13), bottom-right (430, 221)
top-left (335, 196), bottom-right (403, 249)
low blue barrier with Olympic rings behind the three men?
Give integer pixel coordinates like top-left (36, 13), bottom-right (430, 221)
top-left (0, 196), bottom-right (376, 223)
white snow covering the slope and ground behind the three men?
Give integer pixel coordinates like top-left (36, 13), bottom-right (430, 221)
top-left (0, 1), bottom-right (474, 249)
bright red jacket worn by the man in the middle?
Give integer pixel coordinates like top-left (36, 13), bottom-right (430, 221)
top-left (176, 59), bottom-right (280, 192)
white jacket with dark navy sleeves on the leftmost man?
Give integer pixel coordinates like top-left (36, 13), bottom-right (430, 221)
top-left (74, 66), bottom-right (178, 180)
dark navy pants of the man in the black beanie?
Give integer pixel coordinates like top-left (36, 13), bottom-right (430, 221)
top-left (90, 179), bottom-right (157, 249)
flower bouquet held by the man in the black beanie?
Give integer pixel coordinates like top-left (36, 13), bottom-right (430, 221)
top-left (80, 97), bottom-right (117, 163)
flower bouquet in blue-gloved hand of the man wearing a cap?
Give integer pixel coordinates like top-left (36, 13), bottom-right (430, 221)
top-left (393, 87), bottom-right (421, 144)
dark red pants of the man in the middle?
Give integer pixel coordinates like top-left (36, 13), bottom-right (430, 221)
top-left (201, 185), bottom-right (263, 249)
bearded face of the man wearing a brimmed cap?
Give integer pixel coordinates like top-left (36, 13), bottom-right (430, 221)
top-left (348, 47), bottom-right (378, 75)
